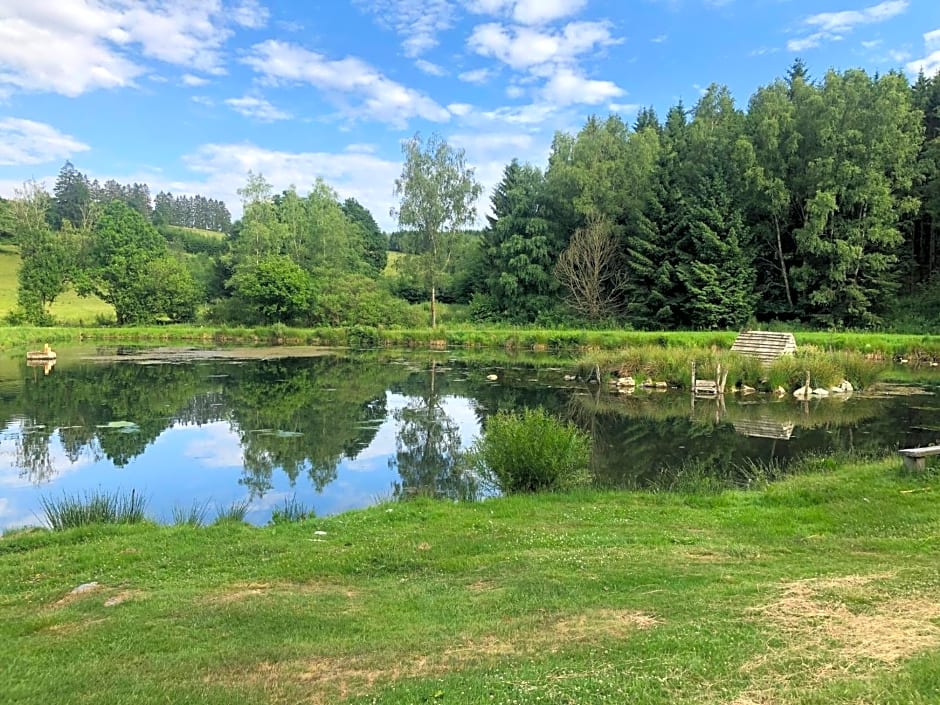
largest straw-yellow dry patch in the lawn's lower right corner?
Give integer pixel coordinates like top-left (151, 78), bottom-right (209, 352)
top-left (731, 573), bottom-right (940, 705)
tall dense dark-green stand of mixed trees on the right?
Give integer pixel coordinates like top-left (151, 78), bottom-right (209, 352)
top-left (475, 61), bottom-right (940, 329)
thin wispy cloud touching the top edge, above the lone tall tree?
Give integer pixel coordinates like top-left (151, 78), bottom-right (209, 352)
top-left (355, 0), bottom-right (455, 58)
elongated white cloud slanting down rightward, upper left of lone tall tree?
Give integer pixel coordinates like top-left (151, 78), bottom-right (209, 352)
top-left (243, 39), bottom-right (450, 127)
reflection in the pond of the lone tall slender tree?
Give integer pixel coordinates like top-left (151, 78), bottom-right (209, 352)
top-left (389, 361), bottom-right (480, 500)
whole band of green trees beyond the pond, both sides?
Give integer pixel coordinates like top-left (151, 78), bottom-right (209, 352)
top-left (0, 61), bottom-right (940, 329)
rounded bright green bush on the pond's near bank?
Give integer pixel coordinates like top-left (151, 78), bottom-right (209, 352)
top-left (471, 408), bottom-right (591, 494)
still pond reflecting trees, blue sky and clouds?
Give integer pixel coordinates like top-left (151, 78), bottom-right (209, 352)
top-left (0, 348), bottom-right (940, 528)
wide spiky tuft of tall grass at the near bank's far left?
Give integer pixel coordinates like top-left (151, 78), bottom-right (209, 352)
top-left (40, 490), bottom-right (147, 531)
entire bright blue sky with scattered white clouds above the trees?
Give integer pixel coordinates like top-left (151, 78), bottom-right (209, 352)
top-left (0, 0), bottom-right (940, 228)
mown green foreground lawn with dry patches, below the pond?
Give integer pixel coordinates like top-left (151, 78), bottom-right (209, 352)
top-left (0, 460), bottom-right (940, 705)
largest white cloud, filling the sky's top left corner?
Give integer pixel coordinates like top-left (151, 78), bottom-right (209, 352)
top-left (0, 0), bottom-right (267, 97)
